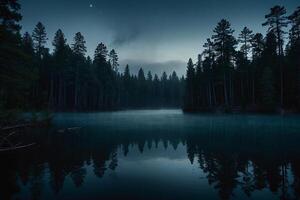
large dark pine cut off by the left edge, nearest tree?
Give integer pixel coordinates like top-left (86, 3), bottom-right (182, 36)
top-left (0, 0), bottom-right (32, 109)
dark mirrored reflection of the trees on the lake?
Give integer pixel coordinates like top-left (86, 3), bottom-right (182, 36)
top-left (0, 119), bottom-right (300, 200)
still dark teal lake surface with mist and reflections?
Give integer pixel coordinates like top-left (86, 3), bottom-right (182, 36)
top-left (0, 110), bottom-right (300, 200)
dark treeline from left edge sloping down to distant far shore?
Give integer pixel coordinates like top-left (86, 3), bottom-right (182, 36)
top-left (0, 0), bottom-right (184, 111)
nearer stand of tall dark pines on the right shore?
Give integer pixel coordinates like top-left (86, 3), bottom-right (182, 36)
top-left (184, 6), bottom-right (300, 111)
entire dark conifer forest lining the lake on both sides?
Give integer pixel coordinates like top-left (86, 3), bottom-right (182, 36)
top-left (0, 0), bottom-right (300, 112)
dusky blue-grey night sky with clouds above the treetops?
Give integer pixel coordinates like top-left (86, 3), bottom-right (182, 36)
top-left (20, 0), bottom-right (300, 74)
